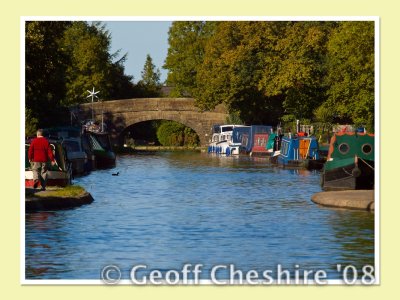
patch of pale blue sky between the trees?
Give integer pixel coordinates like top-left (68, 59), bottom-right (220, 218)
top-left (104, 21), bottom-right (172, 83)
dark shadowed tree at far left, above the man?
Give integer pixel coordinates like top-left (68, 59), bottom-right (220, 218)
top-left (25, 21), bottom-right (72, 127)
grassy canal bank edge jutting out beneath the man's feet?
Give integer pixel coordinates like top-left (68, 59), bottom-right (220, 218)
top-left (25, 189), bottom-right (94, 212)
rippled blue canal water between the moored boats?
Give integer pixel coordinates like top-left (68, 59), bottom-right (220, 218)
top-left (25, 152), bottom-right (374, 280)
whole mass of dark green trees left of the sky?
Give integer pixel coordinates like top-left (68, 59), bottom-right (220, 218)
top-left (25, 21), bottom-right (137, 127)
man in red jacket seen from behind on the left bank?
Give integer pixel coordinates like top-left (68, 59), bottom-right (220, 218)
top-left (28, 129), bottom-right (56, 190)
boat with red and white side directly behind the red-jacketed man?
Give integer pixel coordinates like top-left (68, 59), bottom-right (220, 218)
top-left (25, 139), bottom-right (72, 188)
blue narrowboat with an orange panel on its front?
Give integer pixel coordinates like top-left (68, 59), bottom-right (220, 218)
top-left (277, 136), bottom-right (324, 169)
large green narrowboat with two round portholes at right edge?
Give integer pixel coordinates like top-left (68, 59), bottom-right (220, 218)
top-left (321, 132), bottom-right (375, 190)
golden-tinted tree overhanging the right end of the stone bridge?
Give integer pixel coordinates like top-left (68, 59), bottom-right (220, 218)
top-left (194, 22), bottom-right (282, 124)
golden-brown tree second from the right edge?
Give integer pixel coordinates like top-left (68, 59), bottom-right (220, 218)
top-left (260, 22), bottom-right (335, 123)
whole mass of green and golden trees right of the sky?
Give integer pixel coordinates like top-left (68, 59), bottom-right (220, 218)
top-left (164, 21), bottom-right (375, 129)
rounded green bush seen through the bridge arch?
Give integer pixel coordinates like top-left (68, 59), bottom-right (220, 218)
top-left (157, 121), bottom-right (199, 146)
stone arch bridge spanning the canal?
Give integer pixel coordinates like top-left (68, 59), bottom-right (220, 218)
top-left (79, 98), bottom-right (228, 146)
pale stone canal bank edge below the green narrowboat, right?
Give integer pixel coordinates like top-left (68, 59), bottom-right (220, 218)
top-left (311, 190), bottom-right (375, 211)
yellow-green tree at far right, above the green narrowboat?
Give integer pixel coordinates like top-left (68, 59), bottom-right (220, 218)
top-left (326, 22), bottom-right (375, 130)
